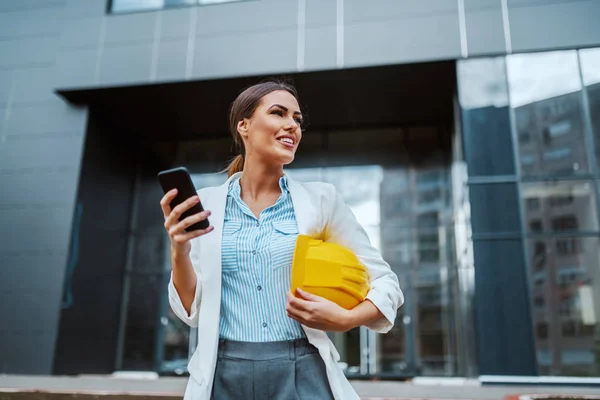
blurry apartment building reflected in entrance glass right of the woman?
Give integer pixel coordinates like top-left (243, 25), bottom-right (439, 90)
top-left (380, 167), bottom-right (459, 375)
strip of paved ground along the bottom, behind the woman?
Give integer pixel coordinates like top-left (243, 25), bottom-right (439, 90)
top-left (0, 375), bottom-right (600, 400)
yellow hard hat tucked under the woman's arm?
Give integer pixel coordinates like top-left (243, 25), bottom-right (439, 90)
top-left (292, 235), bottom-right (369, 309)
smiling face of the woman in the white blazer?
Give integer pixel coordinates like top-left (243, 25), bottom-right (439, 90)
top-left (238, 90), bottom-right (302, 165)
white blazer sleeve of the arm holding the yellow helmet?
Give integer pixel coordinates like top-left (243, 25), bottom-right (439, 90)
top-left (324, 186), bottom-right (404, 333)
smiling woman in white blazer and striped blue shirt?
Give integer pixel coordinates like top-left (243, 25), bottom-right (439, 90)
top-left (161, 82), bottom-right (403, 400)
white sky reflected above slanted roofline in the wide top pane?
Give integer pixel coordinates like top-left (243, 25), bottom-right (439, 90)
top-left (506, 50), bottom-right (581, 107)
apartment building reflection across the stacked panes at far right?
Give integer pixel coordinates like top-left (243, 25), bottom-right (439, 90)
top-left (515, 92), bottom-right (600, 376)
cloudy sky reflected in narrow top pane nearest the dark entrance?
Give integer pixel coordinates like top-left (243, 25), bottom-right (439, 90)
top-left (457, 57), bottom-right (508, 109)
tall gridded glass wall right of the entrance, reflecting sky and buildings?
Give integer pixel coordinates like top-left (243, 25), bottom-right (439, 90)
top-left (458, 49), bottom-right (600, 377)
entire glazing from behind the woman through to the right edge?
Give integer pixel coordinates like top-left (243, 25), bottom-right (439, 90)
top-left (156, 49), bottom-right (600, 377)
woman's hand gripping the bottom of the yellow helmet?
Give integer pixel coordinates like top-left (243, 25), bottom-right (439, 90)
top-left (285, 289), bottom-right (353, 332)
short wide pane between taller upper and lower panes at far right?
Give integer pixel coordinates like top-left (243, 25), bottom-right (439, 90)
top-left (522, 181), bottom-right (598, 233)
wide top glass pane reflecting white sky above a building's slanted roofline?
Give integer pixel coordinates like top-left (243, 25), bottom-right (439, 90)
top-left (507, 51), bottom-right (589, 176)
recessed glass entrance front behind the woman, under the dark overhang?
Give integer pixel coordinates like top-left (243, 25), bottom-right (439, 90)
top-left (157, 122), bottom-right (476, 377)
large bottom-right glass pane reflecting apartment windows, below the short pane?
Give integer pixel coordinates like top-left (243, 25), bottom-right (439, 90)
top-left (528, 237), bottom-right (600, 376)
